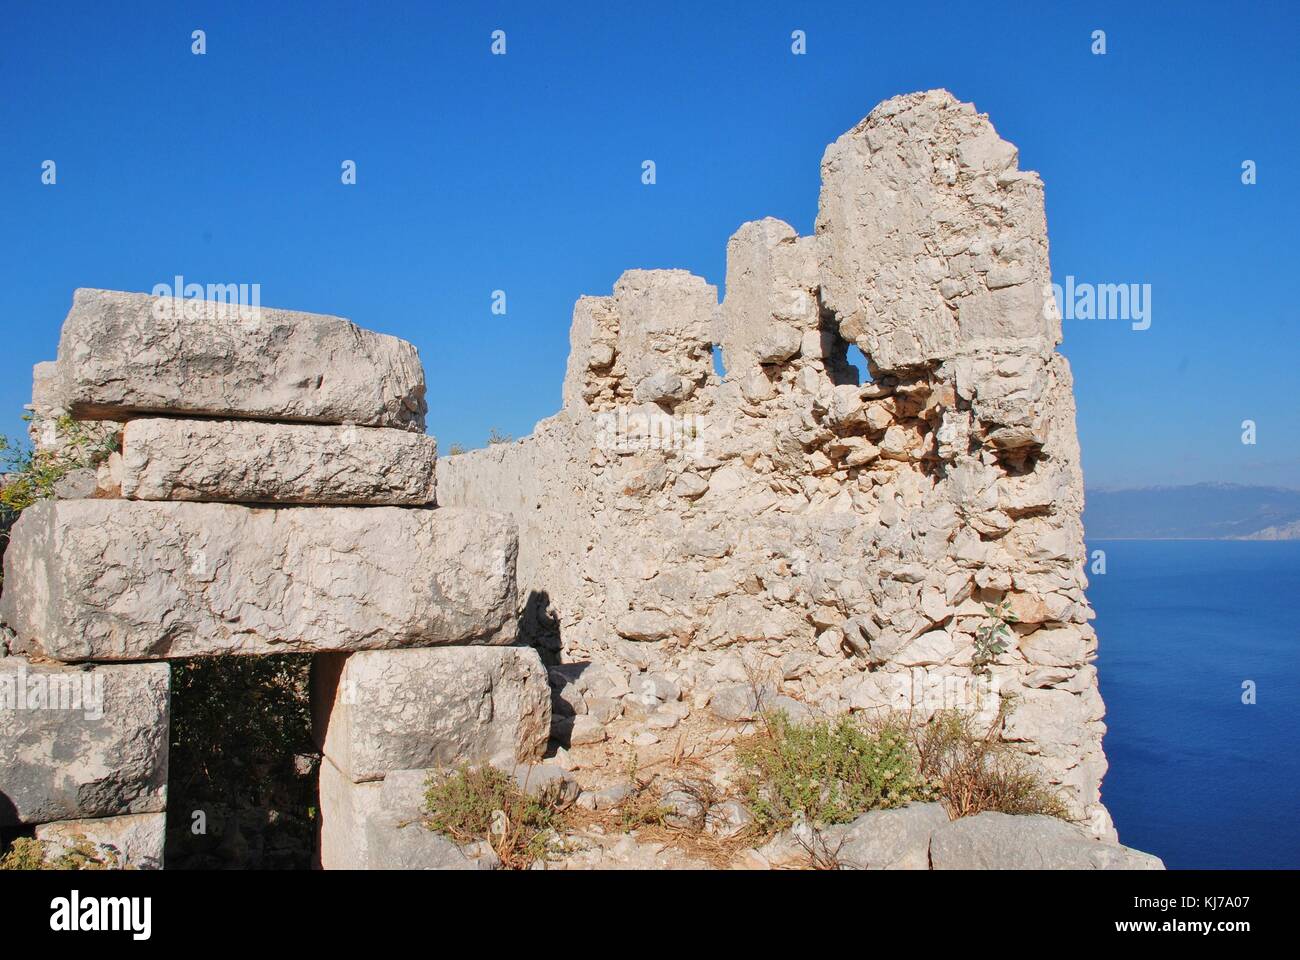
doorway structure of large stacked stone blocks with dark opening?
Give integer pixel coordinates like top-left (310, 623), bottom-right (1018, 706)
top-left (0, 290), bottom-right (551, 869)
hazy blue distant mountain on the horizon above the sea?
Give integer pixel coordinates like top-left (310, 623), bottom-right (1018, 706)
top-left (1083, 484), bottom-right (1300, 540)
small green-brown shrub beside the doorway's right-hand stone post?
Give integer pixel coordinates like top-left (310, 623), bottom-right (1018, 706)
top-left (425, 764), bottom-right (562, 870)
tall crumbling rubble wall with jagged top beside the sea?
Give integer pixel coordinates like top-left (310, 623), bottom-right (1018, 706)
top-left (438, 91), bottom-right (1113, 835)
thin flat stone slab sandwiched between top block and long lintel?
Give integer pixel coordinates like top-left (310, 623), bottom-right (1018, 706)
top-left (121, 419), bottom-right (438, 506)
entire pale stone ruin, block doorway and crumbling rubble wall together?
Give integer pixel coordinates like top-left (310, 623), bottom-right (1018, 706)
top-left (0, 91), bottom-right (1114, 868)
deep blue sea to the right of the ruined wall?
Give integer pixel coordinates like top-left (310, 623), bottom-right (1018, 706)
top-left (1088, 540), bottom-right (1300, 869)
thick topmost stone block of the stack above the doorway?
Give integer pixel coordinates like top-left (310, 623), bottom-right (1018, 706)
top-left (59, 290), bottom-right (428, 432)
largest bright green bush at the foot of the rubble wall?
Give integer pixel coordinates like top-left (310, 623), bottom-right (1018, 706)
top-left (736, 713), bottom-right (923, 833)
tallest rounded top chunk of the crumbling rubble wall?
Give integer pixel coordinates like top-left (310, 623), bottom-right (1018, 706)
top-left (816, 90), bottom-right (1061, 369)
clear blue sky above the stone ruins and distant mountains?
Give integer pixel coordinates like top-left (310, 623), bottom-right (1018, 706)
top-left (0, 0), bottom-right (1300, 487)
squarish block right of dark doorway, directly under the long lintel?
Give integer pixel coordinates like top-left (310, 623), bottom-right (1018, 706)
top-left (312, 647), bottom-right (551, 782)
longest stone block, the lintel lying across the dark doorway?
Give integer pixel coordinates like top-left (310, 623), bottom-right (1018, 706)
top-left (0, 500), bottom-right (517, 661)
